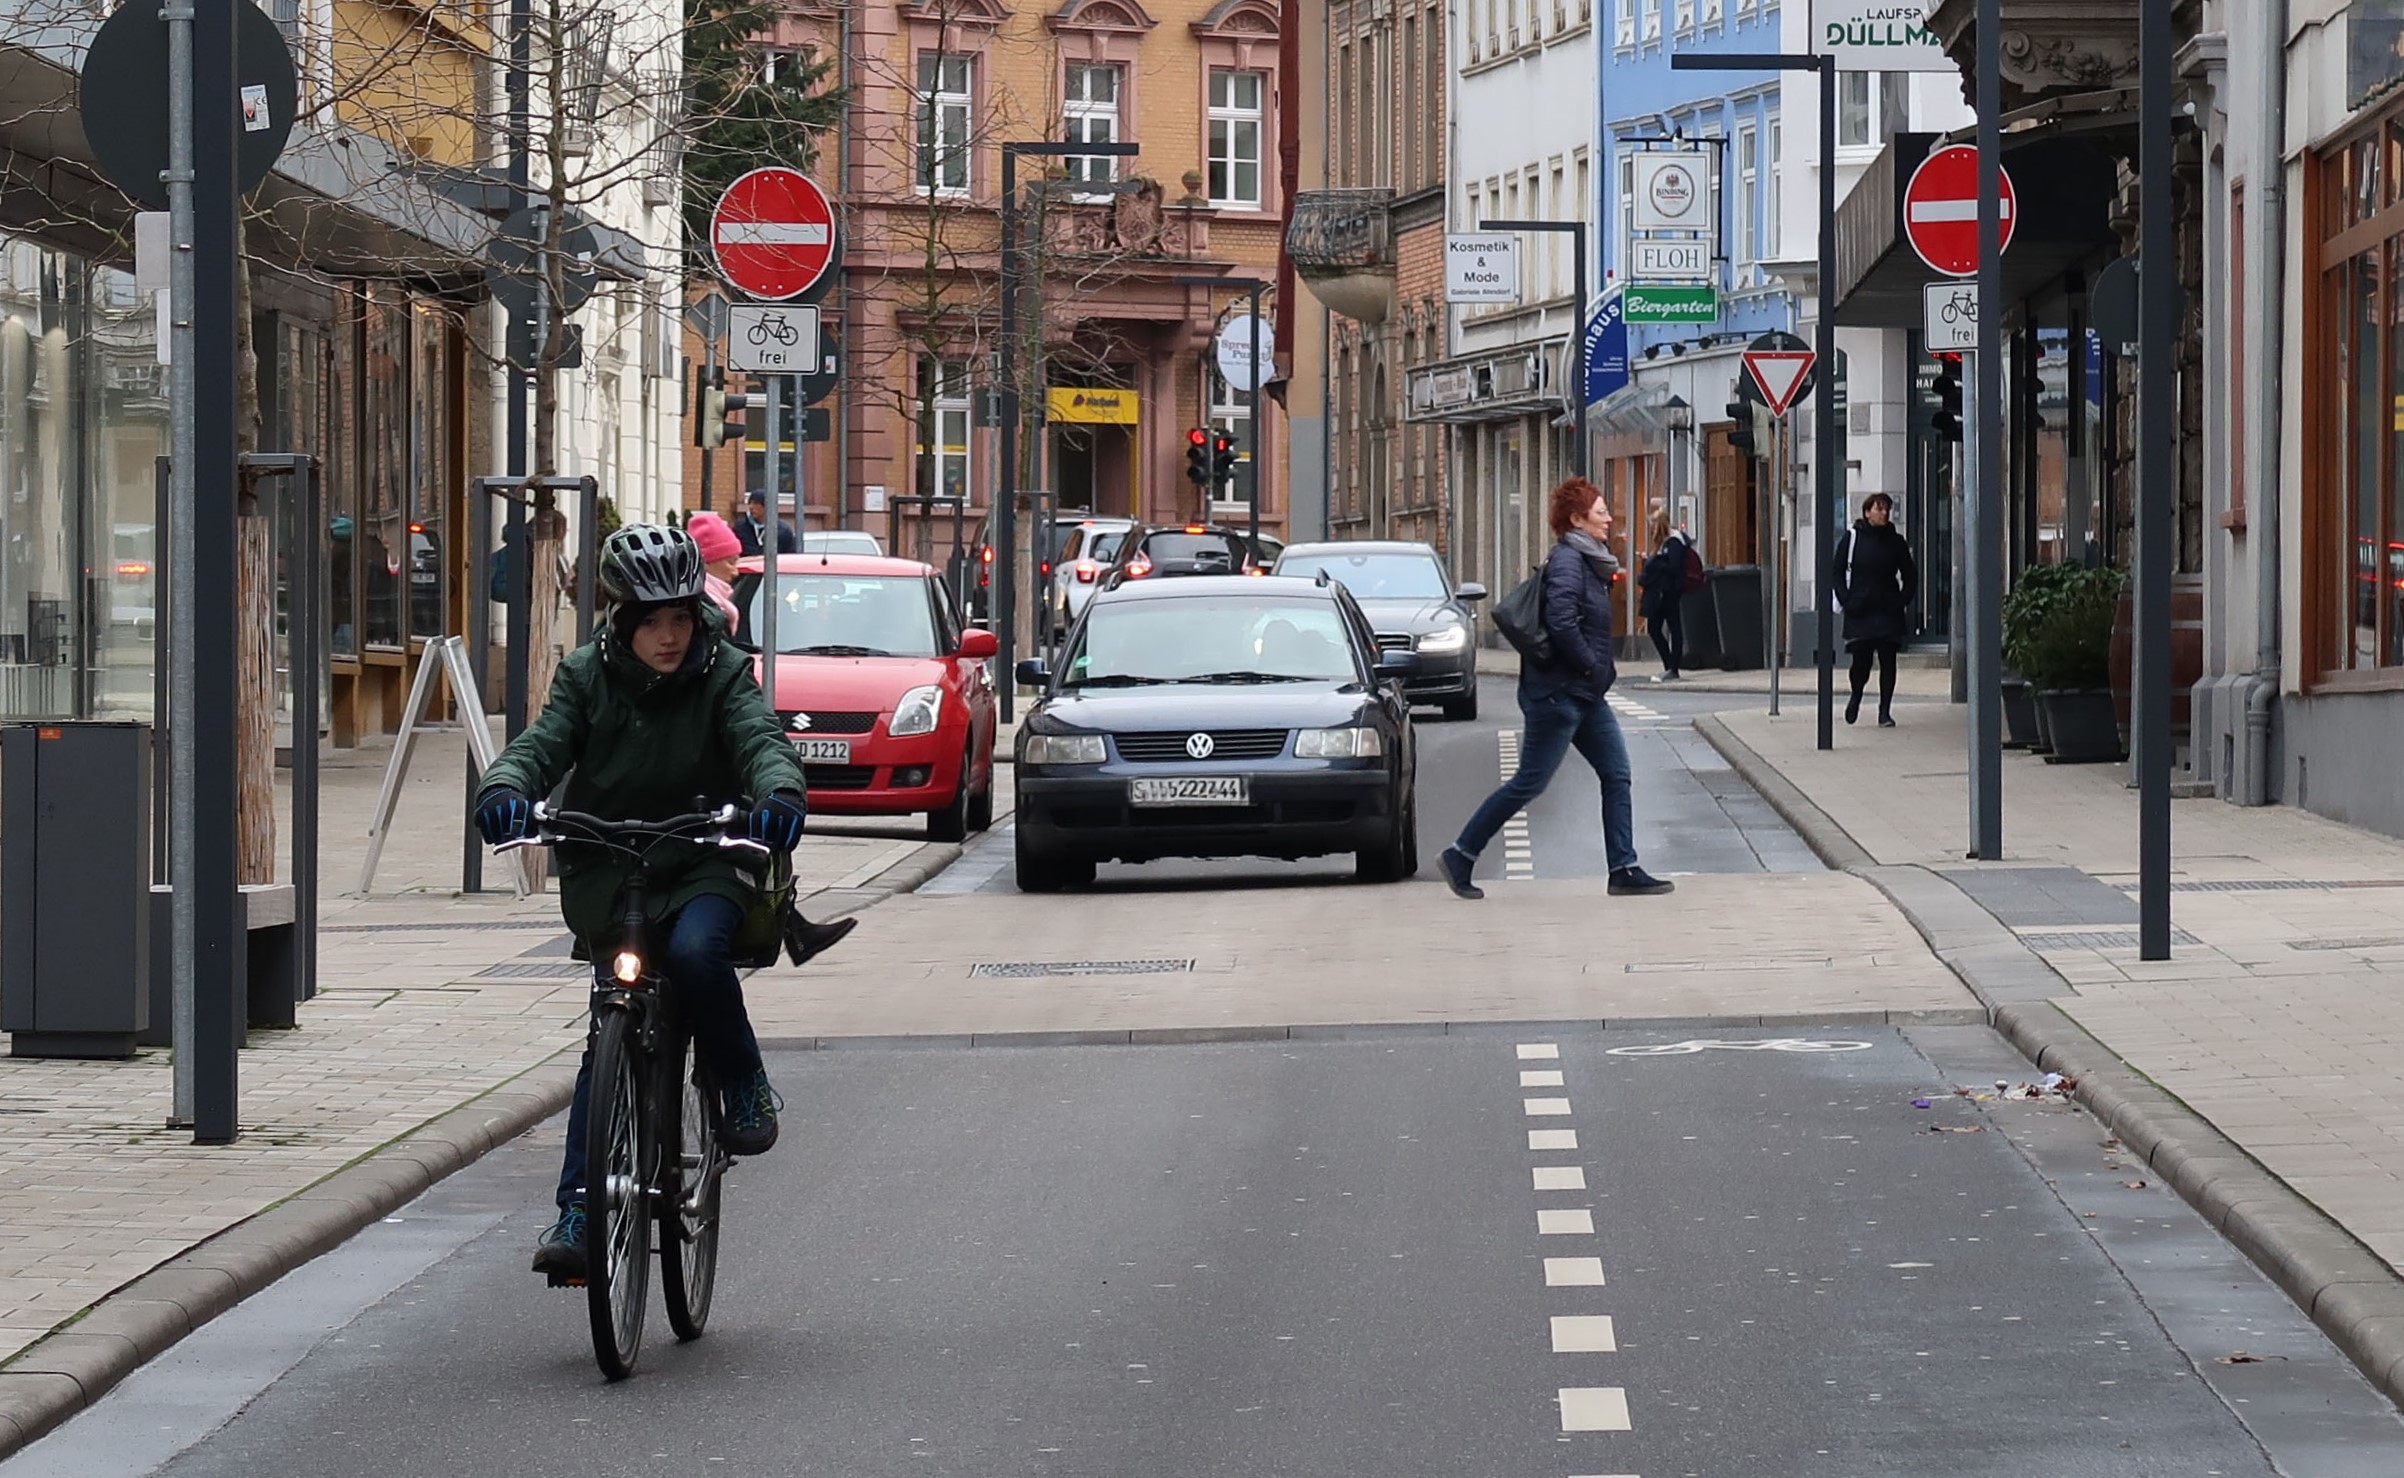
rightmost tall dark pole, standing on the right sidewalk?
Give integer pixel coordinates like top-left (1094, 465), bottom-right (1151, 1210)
top-left (2144, 0), bottom-right (2182, 959)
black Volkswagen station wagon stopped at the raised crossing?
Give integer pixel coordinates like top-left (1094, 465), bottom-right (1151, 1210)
top-left (1014, 574), bottom-right (1418, 892)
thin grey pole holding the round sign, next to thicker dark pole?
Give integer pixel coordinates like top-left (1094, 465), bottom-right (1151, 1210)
top-left (159, 0), bottom-right (200, 1127)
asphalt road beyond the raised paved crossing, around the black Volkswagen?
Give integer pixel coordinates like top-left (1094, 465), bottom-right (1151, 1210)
top-left (923, 675), bottom-right (1820, 894)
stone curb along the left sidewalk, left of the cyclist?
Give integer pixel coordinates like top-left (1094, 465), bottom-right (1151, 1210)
top-left (0, 1050), bottom-right (575, 1459)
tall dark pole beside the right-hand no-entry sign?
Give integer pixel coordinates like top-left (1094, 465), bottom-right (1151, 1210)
top-left (1962, 0), bottom-right (2003, 860)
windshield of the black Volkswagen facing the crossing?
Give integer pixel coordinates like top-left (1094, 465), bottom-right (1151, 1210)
top-left (1063, 596), bottom-right (1361, 687)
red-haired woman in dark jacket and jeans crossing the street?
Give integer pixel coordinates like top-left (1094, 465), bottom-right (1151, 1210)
top-left (1438, 478), bottom-right (1673, 899)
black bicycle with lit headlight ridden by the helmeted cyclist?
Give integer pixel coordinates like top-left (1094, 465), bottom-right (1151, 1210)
top-left (495, 805), bottom-right (774, 1379)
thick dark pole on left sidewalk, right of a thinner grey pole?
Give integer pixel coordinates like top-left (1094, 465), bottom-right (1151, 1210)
top-left (175, 5), bottom-right (248, 1144)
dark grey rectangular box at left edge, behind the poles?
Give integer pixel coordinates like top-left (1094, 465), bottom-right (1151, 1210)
top-left (0, 723), bottom-right (151, 1057)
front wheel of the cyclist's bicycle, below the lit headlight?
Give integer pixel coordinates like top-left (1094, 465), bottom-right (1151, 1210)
top-left (584, 1009), bottom-right (656, 1379)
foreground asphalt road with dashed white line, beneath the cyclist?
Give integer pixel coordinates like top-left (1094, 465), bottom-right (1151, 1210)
top-left (18, 1026), bottom-right (2404, 1478)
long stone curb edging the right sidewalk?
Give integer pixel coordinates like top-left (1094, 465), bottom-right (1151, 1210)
top-left (1695, 716), bottom-right (2404, 1406)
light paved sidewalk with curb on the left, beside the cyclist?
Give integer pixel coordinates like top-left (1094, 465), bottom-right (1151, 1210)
top-left (0, 731), bottom-right (976, 1454)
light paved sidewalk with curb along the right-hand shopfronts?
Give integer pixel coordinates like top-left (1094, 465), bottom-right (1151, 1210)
top-left (1700, 701), bottom-right (2404, 1396)
